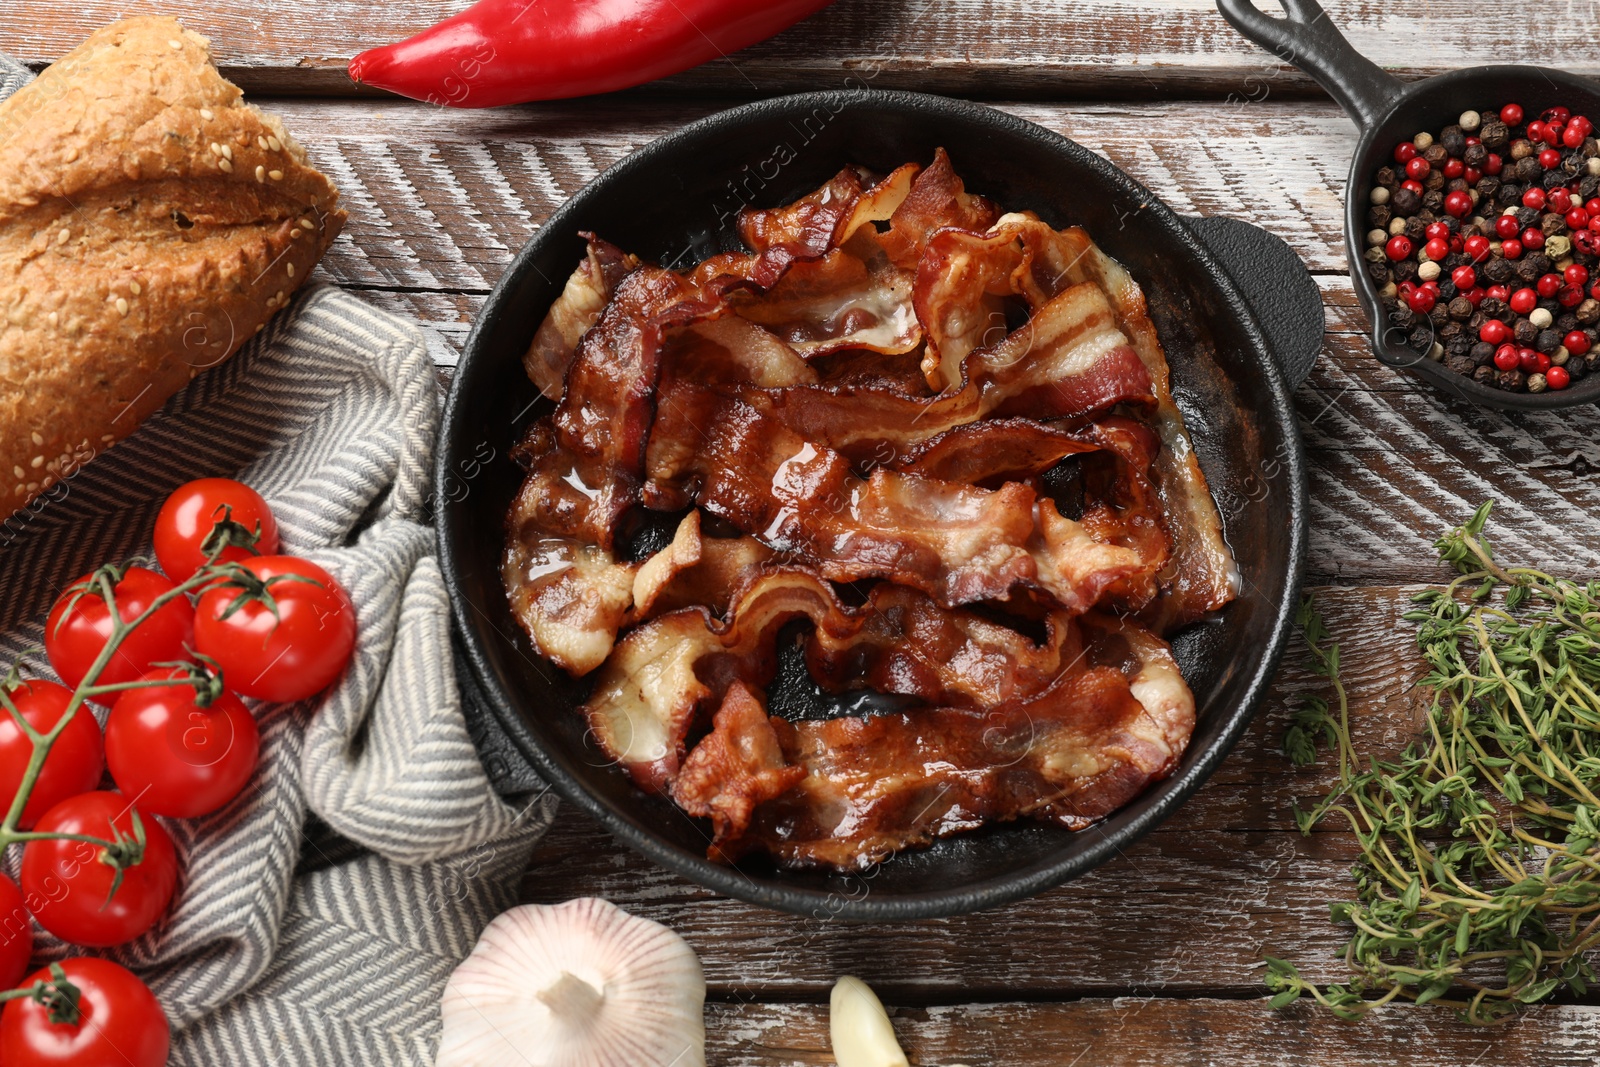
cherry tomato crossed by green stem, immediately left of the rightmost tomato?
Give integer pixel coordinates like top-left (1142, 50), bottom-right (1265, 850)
top-left (45, 566), bottom-right (195, 688)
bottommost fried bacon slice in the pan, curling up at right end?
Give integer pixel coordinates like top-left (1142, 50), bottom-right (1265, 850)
top-left (672, 617), bottom-right (1195, 870)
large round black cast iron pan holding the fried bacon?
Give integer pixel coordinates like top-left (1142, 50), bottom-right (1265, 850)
top-left (438, 91), bottom-right (1322, 920)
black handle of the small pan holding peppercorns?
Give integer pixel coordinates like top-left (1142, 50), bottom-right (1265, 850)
top-left (1216, 0), bottom-right (1403, 130)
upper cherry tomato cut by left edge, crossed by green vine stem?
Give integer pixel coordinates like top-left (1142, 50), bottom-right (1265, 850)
top-left (0, 680), bottom-right (106, 831)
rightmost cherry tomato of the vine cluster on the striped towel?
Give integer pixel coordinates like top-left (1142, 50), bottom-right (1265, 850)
top-left (195, 555), bottom-right (355, 702)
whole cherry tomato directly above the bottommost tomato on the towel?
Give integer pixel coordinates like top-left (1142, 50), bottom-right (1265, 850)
top-left (22, 792), bottom-right (178, 949)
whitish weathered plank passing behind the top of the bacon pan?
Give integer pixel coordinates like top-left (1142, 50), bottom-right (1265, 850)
top-left (275, 99), bottom-right (1354, 291)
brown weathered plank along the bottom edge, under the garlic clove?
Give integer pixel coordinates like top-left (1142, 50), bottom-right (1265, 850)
top-left (706, 997), bottom-right (1600, 1067)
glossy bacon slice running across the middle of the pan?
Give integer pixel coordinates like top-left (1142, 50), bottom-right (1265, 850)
top-left (643, 376), bottom-right (1147, 611)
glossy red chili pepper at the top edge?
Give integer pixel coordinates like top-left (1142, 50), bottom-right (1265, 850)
top-left (350, 0), bottom-right (832, 107)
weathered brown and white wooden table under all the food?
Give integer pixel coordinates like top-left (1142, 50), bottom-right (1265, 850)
top-left (12, 0), bottom-right (1600, 1067)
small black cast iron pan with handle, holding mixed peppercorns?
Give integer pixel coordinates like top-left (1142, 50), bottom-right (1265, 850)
top-left (1216, 0), bottom-right (1600, 411)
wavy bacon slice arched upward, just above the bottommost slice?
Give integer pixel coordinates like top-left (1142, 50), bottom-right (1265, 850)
top-left (581, 566), bottom-right (1082, 792)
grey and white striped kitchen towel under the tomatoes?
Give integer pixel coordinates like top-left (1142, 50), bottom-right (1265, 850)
top-left (0, 51), bottom-right (555, 1067)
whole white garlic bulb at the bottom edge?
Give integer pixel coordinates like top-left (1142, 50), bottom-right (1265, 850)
top-left (435, 897), bottom-right (706, 1067)
